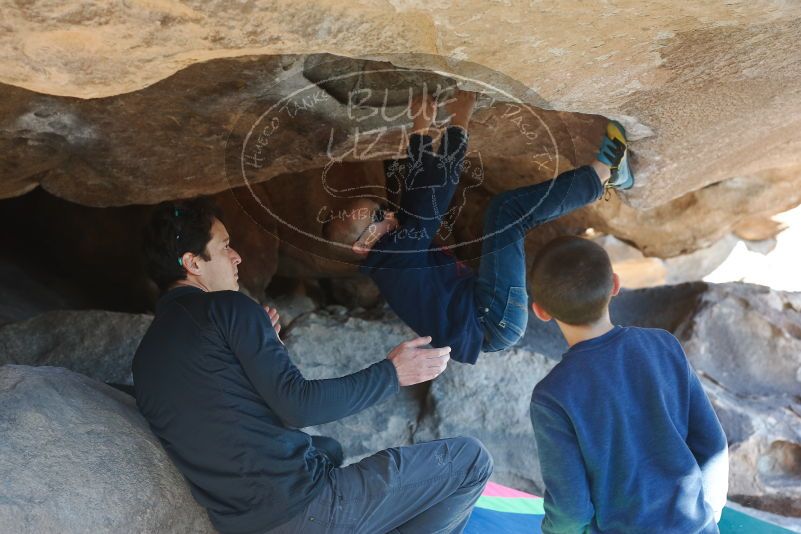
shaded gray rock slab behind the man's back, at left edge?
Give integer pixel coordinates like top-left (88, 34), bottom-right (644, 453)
top-left (0, 310), bottom-right (153, 384)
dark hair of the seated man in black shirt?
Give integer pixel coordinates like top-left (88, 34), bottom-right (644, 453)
top-left (142, 197), bottom-right (222, 293)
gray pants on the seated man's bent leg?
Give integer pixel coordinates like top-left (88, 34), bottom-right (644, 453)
top-left (269, 437), bottom-right (492, 534)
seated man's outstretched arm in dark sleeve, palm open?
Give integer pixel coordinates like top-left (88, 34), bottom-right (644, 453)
top-left (212, 291), bottom-right (450, 428)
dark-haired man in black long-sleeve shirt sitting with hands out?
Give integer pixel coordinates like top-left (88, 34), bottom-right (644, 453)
top-left (133, 201), bottom-right (491, 534)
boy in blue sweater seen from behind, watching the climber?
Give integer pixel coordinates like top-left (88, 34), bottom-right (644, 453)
top-left (531, 237), bottom-right (728, 534)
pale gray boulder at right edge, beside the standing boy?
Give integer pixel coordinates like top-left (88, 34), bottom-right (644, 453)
top-left (677, 284), bottom-right (801, 517)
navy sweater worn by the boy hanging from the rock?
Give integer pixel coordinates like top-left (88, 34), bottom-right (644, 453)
top-left (360, 127), bottom-right (484, 363)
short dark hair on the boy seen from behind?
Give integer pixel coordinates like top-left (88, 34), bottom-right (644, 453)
top-left (532, 236), bottom-right (614, 326)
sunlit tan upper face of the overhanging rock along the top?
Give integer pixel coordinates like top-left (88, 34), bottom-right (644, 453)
top-left (0, 0), bottom-right (801, 214)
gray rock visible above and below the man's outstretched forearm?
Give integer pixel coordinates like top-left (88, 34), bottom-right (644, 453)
top-left (279, 307), bottom-right (425, 457)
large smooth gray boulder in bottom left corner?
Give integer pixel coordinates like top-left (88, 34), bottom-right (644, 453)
top-left (0, 365), bottom-right (214, 534)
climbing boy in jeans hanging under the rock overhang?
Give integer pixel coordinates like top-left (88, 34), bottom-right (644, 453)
top-left (323, 91), bottom-right (634, 364)
